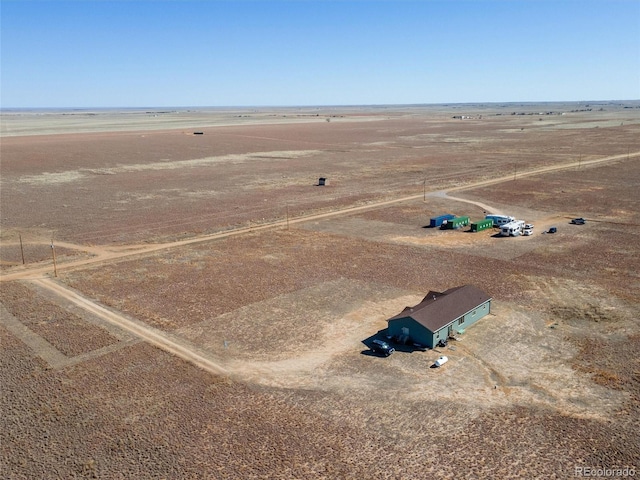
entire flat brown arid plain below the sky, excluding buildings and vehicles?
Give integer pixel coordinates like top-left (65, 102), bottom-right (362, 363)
top-left (0, 101), bottom-right (640, 479)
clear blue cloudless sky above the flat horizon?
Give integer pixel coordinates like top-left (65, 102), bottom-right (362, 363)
top-left (0, 0), bottom-right (640, 108)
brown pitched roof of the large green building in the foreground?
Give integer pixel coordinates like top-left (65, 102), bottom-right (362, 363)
top-left (389, 285), bottom-right (491, 332)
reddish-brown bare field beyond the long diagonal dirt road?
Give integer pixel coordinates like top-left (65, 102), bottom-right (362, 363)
top-left (0, 106), bottom-right (640, 251)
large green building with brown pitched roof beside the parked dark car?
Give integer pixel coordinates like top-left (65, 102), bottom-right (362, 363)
top-left (387, 285), bottom-right (491, 348)
